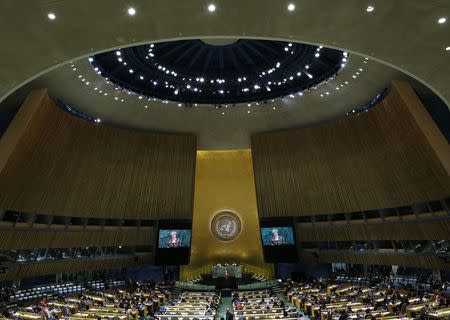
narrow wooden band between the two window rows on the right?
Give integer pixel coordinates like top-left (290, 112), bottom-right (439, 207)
top-left (295, 220), bottom-right (450, 241)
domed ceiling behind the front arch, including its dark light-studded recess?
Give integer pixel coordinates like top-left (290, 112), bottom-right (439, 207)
top-left (0, 38), bottom-right (420, 150)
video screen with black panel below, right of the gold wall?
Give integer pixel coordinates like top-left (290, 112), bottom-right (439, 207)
top-left (260, 219), bottom-right (297, 263)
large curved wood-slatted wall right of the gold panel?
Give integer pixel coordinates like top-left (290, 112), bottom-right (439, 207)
top-left (252, 82), bottom-right (450, 218)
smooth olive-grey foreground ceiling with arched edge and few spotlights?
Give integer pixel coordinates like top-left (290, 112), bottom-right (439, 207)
top-left (0, 0), bottom-right (450, 109)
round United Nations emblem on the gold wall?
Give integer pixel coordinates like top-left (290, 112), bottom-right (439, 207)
top-left (210, 210), bottom-right (241, 241)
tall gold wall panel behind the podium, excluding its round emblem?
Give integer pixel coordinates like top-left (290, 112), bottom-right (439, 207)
top-left (181, 150), bottom-right (273, 280)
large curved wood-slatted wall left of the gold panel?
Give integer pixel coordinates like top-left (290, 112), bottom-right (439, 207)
top-left (0, 90), bottom-right (196, 219)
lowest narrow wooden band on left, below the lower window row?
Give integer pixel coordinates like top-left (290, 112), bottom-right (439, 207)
top-left (0, 254), bottom-right (154, 281)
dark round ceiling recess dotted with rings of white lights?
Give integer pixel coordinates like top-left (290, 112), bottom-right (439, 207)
top-left (89, 40), bottom-right (348, 107)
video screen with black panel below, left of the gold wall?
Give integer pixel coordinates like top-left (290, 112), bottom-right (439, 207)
top-left (156, 220), bottom-right (192, 265)
